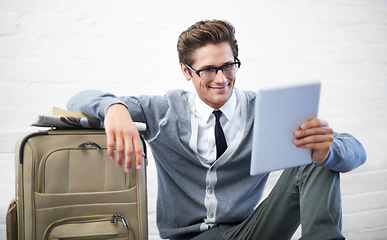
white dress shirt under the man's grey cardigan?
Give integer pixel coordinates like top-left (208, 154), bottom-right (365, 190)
top-left (193, 92), bottom-right (241, 163)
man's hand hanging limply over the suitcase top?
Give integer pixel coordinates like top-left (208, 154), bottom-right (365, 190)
top-left (104, 104), bottom-right (143, 172)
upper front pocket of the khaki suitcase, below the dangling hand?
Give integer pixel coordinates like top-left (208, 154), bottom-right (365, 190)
top-left (37, 143), bottom-right (135, 193)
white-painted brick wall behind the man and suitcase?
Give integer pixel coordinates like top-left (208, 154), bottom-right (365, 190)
top-left (0, 0), bottom-right (387, 239)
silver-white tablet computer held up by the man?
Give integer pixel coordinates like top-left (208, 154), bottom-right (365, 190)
top-left (250, 80), bottom-right (321, 175)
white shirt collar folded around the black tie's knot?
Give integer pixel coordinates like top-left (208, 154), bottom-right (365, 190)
top-left (195, 91), bottom-right (237, 122)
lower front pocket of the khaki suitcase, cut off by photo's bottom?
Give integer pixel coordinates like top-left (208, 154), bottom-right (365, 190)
top-left (43, 214), bottom-right (134, 240)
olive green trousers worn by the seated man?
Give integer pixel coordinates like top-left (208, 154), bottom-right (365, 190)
top-left (193, 164), bottom-right (345, 240)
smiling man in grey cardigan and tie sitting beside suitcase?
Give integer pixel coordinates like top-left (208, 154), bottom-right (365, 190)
top-left (68, 20), bottom-right (366, 240)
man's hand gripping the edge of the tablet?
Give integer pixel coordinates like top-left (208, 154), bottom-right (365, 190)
top-left (293, 118), bottom-right (333, 164)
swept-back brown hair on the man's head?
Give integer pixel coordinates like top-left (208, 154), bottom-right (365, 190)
top-left (177, 20), bottom-right (238, 65)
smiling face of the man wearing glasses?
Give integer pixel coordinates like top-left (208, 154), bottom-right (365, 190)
top-left (181, 42), bottom-right (235, 109)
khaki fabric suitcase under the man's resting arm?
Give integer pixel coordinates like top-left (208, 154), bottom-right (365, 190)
top-left (15, 130), bottom-right (148, 240)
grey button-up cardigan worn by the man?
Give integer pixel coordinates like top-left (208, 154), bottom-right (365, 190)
top-left (67, 89), bottom-right (365, 238)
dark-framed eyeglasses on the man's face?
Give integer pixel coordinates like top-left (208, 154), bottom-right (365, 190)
top-left (185, 58), bottom-right (241, 81)
